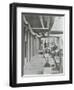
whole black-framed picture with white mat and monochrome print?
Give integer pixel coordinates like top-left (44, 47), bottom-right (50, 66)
top-left (9, 3), bottom-right (72, 87)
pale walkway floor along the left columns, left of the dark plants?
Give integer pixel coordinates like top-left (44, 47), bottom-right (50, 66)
top-left (24, 55), bottom-right (45, 75)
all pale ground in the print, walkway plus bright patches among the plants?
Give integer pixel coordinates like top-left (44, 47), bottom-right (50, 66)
top-left (24, 54), bottom-right (62, 75)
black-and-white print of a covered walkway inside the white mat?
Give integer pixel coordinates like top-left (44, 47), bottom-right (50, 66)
top-left (22, 13), bottom-right (64, 76)
